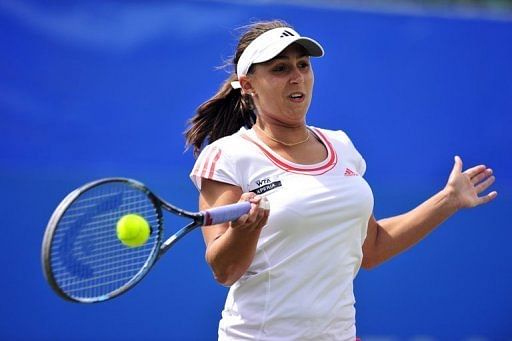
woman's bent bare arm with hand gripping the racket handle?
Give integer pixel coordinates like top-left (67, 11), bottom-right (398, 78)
top-left (199, 178), bottom-right (269, 286)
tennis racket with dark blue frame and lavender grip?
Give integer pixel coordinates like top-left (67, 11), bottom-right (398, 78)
top-left (42, 178), bottom-right (251, 303)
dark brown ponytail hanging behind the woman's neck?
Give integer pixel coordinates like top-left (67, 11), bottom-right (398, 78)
top-left (185, 73), bottom-right (256, 157)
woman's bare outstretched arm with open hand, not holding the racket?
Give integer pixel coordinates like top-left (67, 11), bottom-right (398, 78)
top-left (362, 156), bottom-right (498, 269)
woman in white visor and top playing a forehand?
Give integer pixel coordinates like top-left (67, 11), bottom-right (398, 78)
top-left (186, 21), bottom-right (497, 340)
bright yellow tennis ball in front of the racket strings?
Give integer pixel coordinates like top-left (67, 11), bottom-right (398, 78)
top-left (116, 214), bottom-right (151, 247)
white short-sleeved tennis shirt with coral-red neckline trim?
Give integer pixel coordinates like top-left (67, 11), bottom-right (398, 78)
top-left (190, 127), bottom-right (373, 341)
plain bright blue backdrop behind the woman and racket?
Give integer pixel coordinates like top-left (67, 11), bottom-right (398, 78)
top-left (0, 0), bottom-right (512, 340)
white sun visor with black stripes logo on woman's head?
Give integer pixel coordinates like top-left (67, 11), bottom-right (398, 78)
top-left (231, 27), bottom-right (324, 89)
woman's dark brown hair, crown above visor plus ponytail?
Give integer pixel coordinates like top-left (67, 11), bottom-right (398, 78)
top-left (185, 20), bottom-right (291, 156)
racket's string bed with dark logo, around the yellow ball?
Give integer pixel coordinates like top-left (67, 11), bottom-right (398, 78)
top-left (50, 183), bottom-right (161, 300)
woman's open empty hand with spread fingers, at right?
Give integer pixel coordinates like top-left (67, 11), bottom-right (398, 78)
top-left (445, 156), bottom-right (498, 209)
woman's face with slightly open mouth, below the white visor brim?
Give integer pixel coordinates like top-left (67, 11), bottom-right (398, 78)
top-left (242, 44), bottom-right (314, 126)
